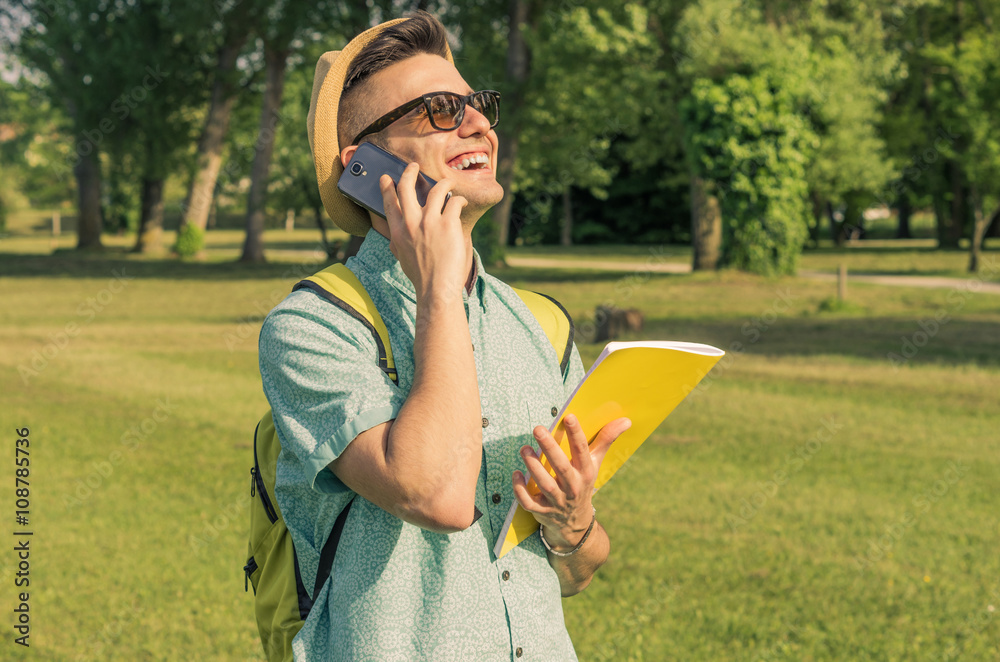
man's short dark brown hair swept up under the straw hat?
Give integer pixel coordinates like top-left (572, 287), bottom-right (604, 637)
top-left (337, 11), bottom-right (448, 149)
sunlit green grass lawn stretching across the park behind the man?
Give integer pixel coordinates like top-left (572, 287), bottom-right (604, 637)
top-left (0, 230), bottom-right (1000, 661)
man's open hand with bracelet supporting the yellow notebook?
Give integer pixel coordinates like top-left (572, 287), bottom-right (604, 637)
top-left (514, 414), bottom-right (632, 551)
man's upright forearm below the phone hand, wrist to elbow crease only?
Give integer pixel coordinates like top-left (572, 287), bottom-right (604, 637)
top-left (385, 290), bottom-right (483, 521)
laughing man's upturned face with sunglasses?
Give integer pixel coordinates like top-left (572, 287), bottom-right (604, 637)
top-left (356, 53), bottom-right (503, 222)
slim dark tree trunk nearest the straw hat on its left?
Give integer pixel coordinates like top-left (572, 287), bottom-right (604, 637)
top-left (240, 44), bottom-right (288, 262)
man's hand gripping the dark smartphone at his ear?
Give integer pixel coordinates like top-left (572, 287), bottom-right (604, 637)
top-left (379, 163), bottom-right (472, 299)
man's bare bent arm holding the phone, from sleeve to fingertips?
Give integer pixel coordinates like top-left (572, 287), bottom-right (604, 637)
top-left (329, 168), bottom-right (483, 533)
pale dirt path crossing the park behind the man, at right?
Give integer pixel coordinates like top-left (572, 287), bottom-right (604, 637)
top-left (507, 256), bottom-right (1000, 294)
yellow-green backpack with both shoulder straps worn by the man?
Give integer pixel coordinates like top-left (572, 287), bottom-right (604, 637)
top-left (243, 264), bottom-right (574, 662)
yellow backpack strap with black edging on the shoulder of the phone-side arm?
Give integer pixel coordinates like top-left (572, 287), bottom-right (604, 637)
top-left (292, 263), bottom-right (398, 383)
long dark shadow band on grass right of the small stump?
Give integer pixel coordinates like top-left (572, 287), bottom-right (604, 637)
top-left (636, 315), bottom-right (1000, 369)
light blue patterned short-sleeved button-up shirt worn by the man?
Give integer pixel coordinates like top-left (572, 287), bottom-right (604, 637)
top-left (260, 230), bottom-right (584, 662)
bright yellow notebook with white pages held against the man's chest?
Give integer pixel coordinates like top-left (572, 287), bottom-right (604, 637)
top-left (493, 341), bottom-right (725, 558)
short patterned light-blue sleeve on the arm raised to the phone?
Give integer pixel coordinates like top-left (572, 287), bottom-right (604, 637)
top-left (259, 291), bottom-right (405, 492)
